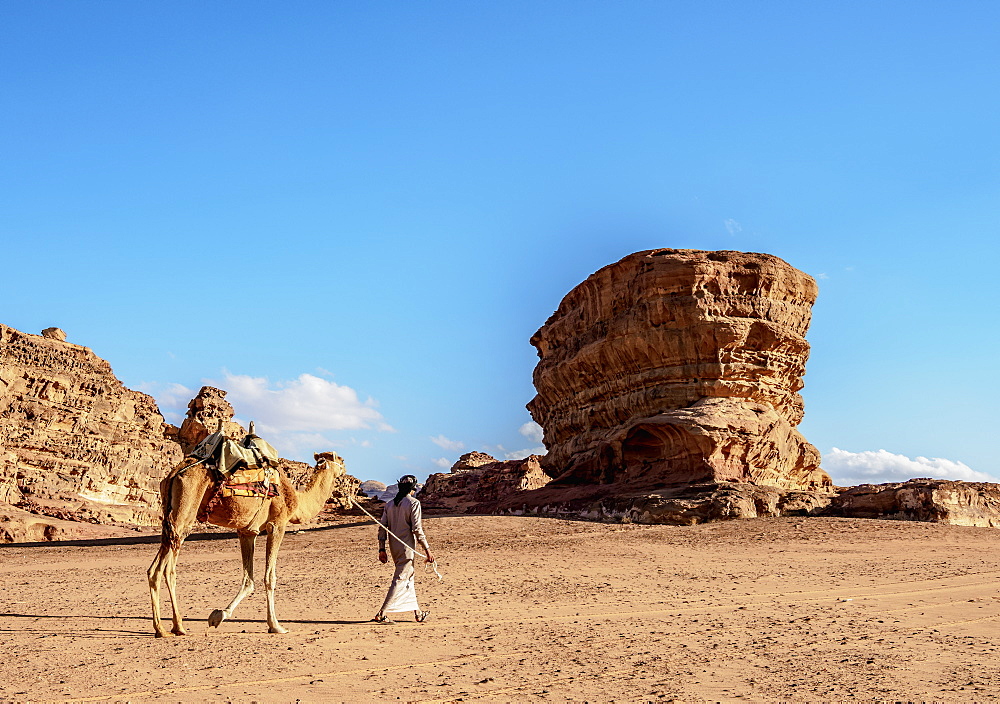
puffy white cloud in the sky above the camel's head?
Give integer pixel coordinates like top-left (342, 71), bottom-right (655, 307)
top-left (210, 372), bottom-right (393, 433)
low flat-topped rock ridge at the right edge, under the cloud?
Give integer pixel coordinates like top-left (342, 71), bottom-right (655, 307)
top-left (826, 479), bottom-right (1000, 528)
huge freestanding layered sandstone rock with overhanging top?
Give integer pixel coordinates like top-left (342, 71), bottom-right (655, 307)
top-left (528, 249), bottom-right (832, 496)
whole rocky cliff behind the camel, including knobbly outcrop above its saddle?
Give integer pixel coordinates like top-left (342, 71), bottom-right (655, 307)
top-left (0, 325), bottom-right (368, 542)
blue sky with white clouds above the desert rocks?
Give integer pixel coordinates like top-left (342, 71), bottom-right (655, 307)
top-left (0, 0), bottom-right (1000, 483)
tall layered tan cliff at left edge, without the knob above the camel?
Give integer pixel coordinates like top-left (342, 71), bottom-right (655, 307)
top-left (0, 325), bottom-right (182, 537)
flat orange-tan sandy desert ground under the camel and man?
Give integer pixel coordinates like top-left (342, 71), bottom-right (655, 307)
top-left (0, 517), bottom-right (1000, 702)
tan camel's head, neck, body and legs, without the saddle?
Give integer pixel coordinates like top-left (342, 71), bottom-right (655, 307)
top-left (146, 452), bottom-right (347, 638)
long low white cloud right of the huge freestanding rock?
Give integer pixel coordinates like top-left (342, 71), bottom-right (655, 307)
top-left (823, 447), bottom-right (997, 486)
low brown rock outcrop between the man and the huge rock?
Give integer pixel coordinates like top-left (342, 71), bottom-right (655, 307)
top-left (417, 452), bottom-right (551, 513)
